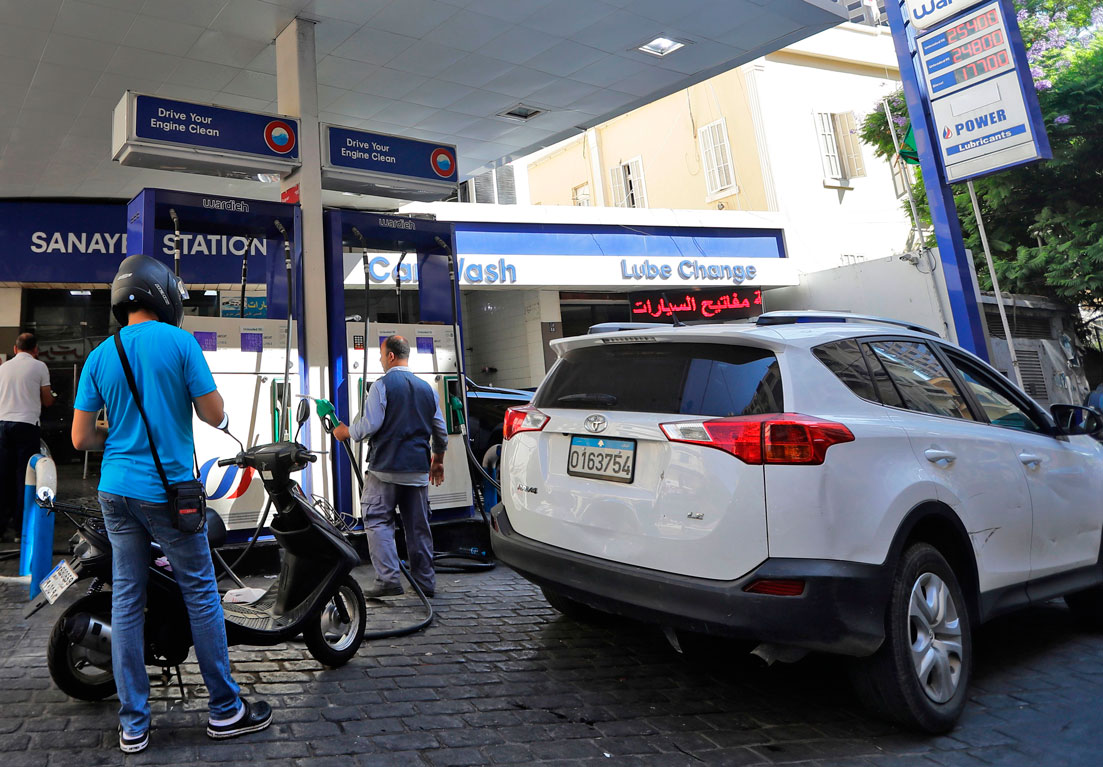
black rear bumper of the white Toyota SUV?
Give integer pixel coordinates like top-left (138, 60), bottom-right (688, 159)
top-left (491, 503), bottom-right (891, 656)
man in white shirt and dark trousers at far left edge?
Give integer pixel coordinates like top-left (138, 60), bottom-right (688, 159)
top-left (0, 333), bottom-right (55, 540)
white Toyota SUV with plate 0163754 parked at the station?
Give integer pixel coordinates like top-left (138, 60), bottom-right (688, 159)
top-left (492, 312), bottom-right (1103, 732)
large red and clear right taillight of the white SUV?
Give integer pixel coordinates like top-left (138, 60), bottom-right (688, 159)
top-left (660, 413), bottom-right (854, 465)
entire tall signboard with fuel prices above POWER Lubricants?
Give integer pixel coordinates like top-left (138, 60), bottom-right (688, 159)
top-left (908, 0), bottom-right (1052, 182)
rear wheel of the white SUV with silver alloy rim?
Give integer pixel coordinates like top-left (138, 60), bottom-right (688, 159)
top-left (855, 543), bottom-right (973, 733)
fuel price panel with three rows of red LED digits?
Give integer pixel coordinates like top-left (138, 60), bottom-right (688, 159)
top-left (919, 4), bottom-right (1015, 99)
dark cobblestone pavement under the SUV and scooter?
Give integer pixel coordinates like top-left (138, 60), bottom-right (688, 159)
top-left (0, 567), bottom-right (1103, 767)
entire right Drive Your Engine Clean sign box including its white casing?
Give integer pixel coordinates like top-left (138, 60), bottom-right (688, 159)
top-left (322, 125), bottom-right (460, 201)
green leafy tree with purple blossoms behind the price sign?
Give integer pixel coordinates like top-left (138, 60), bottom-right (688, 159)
top-left (860, 0), bottom-right (1103, 309)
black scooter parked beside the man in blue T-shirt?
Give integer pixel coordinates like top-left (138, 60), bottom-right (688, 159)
top-left (28, 402), bottom-right (366, 701)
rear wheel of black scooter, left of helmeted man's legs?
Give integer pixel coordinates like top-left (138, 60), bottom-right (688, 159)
top-left (46, 593), bottom-right (116, 701)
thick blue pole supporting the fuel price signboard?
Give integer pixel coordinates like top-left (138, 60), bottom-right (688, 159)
top-left (886, 0), bottom-right (988, 361)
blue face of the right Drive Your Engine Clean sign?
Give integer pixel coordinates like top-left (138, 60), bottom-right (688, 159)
top-left (325, 126), bottom-right (459, 183)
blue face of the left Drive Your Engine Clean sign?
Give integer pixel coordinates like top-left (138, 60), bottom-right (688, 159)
top-left (135, 95), bottom-right (299, 160)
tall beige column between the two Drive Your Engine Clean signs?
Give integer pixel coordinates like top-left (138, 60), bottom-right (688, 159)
top-left (276, 19), bottom-right (333, 498)
